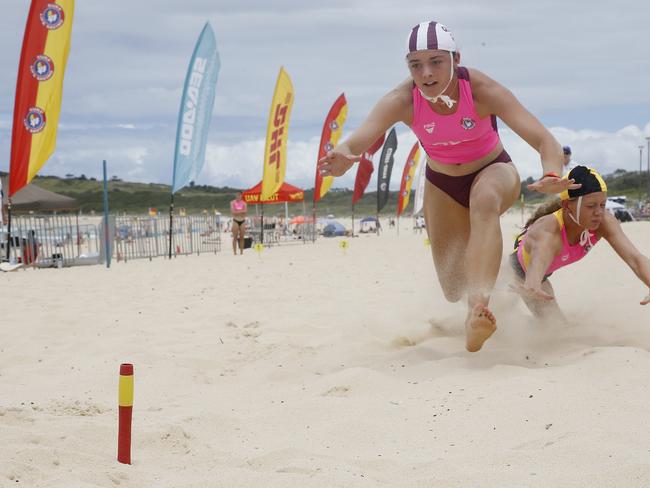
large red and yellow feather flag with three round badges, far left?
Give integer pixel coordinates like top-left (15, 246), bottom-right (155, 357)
top-left (9, 0), bottom-right (74, 196)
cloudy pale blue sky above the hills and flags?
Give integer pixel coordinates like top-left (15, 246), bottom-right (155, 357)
top-left (0, 0), bottom-right (650, 189)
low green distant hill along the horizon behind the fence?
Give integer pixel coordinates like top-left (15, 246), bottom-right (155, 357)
top-left (5, 169), bottom-right (650, 216)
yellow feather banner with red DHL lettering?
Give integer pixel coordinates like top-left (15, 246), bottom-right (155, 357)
top-left (261, 68), bottom-right (293, 200)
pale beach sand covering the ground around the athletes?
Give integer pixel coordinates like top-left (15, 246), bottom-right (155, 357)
top-left (0, 216), bottom-right (650, 488)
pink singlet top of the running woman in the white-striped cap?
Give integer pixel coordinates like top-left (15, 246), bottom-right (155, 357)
top-left (411, 67), bottom-right (499, 164)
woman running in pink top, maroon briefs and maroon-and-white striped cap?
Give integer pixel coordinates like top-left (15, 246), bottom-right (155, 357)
top-left (318, 22), bottom-right (572, 351)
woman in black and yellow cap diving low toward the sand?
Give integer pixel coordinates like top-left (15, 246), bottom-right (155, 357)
top-left (510, 166), bottom-right (650, 319)
